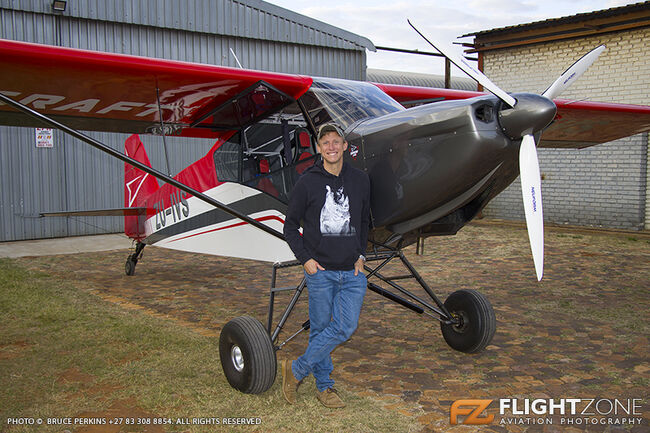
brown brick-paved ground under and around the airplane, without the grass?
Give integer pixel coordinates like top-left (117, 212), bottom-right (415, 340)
top-left (19, 223), bottom-right (650, 433)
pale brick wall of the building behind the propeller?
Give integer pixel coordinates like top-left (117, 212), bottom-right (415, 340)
top-left (484, 28), bottom-right (650, 230)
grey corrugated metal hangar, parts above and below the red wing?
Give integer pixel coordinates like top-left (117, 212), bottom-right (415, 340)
top-left (0, 0), bottom-right (372, 241)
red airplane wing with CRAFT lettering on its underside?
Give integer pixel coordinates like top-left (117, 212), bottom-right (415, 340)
top-left (0, 40), bottom-right (312, 138)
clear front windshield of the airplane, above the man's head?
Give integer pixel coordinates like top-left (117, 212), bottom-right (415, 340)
top-left (310, 78), bottom-right (404, 129)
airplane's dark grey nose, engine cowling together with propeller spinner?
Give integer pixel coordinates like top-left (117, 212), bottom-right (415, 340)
top-left (346, 94), bottom-right (555, 243)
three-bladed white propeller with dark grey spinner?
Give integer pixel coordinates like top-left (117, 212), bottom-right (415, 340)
top-left (407, 20), bottom-right (605, 281)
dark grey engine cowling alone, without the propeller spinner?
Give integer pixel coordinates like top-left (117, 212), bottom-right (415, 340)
top-left (347, 96), bottom-right (518, 230)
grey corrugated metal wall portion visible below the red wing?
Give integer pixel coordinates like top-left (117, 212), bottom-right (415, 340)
top-left (0, 127), bottom-right (212, 241)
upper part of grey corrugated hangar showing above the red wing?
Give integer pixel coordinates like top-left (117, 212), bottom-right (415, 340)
top-left (0, 0), bottom-right (374, 80)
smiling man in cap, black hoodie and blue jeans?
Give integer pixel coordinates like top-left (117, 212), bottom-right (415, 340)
top-left (282, 124), bottom-right (370, 408)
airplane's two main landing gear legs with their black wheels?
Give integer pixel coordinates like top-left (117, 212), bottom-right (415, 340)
top-left (219, 241), bottom-right (496, 394)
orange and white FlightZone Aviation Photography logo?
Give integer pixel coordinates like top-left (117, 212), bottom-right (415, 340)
top-left (449, 398), bottom-right (647, 426)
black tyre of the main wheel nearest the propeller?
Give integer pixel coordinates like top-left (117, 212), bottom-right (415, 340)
top-left (440, 290), bottom-right (497, 353)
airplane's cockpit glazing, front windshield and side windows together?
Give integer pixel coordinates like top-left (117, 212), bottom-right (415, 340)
top-left (213, 78), bottom-right (404, 203)
